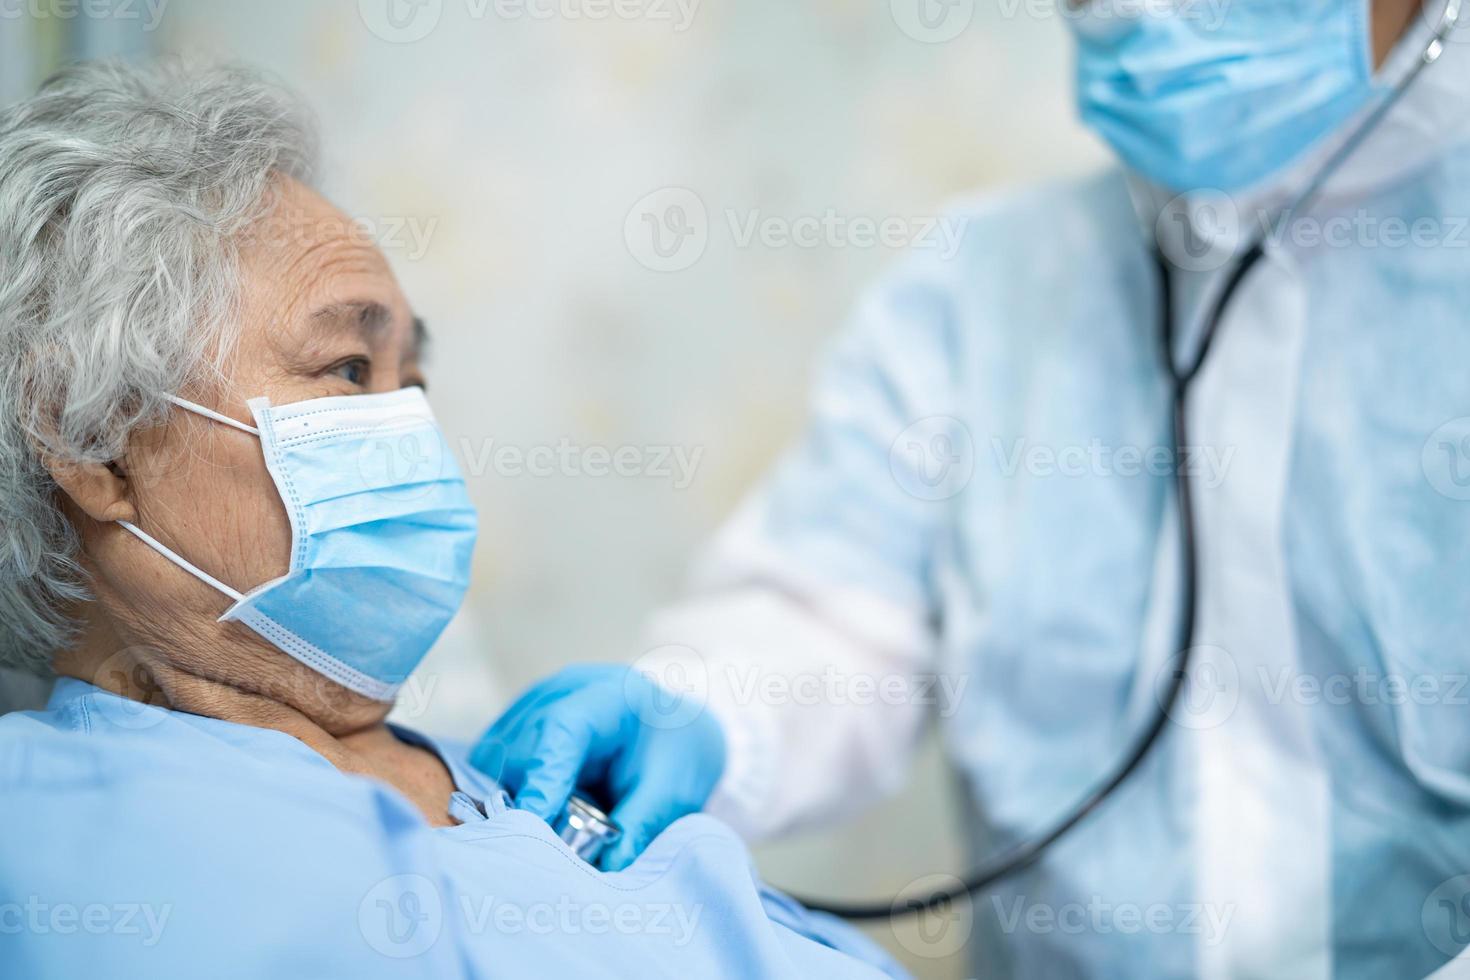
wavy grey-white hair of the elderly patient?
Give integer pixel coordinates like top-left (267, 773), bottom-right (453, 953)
top-left (0, 62), bottom-right (316, 674)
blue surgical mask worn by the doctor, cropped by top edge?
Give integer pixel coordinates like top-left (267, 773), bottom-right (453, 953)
top-left (1072, 0), bottom-right (1373, 192)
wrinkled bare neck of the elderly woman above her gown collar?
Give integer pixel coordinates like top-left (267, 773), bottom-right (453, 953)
top-left (53, 619), bottom-right (454, 826)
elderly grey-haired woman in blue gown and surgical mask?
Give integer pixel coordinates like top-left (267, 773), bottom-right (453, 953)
top-left (0, 65), bottom-right (897, 977)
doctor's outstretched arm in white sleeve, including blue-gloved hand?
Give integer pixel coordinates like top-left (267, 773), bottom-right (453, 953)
top-left (473, 255), bottom-right (969, 868)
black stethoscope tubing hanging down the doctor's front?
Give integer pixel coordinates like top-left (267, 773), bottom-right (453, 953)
top-left (797, 0), bottom-right (1463, 920)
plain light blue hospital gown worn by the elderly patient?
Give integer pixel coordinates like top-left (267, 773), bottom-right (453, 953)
top-left (0, 679), bottom-right (903, 980)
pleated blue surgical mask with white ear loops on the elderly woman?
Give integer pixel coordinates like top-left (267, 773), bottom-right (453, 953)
top-left (119, 388), bottom-right (476, 701)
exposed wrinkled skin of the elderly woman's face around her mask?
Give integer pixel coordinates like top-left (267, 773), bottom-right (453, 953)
top-left (84, 182), bottom-right (423, 720)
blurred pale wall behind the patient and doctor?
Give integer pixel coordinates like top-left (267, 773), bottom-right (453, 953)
top-left (0, 0), bottom-right (1103, 977)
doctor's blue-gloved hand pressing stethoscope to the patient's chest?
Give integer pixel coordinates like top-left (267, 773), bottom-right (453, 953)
top-left (470, 664), bottom-right (725, 871)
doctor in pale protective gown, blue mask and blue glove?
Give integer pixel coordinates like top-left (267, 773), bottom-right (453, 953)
top-left (476, 0), bottom-right (1470, 977)
